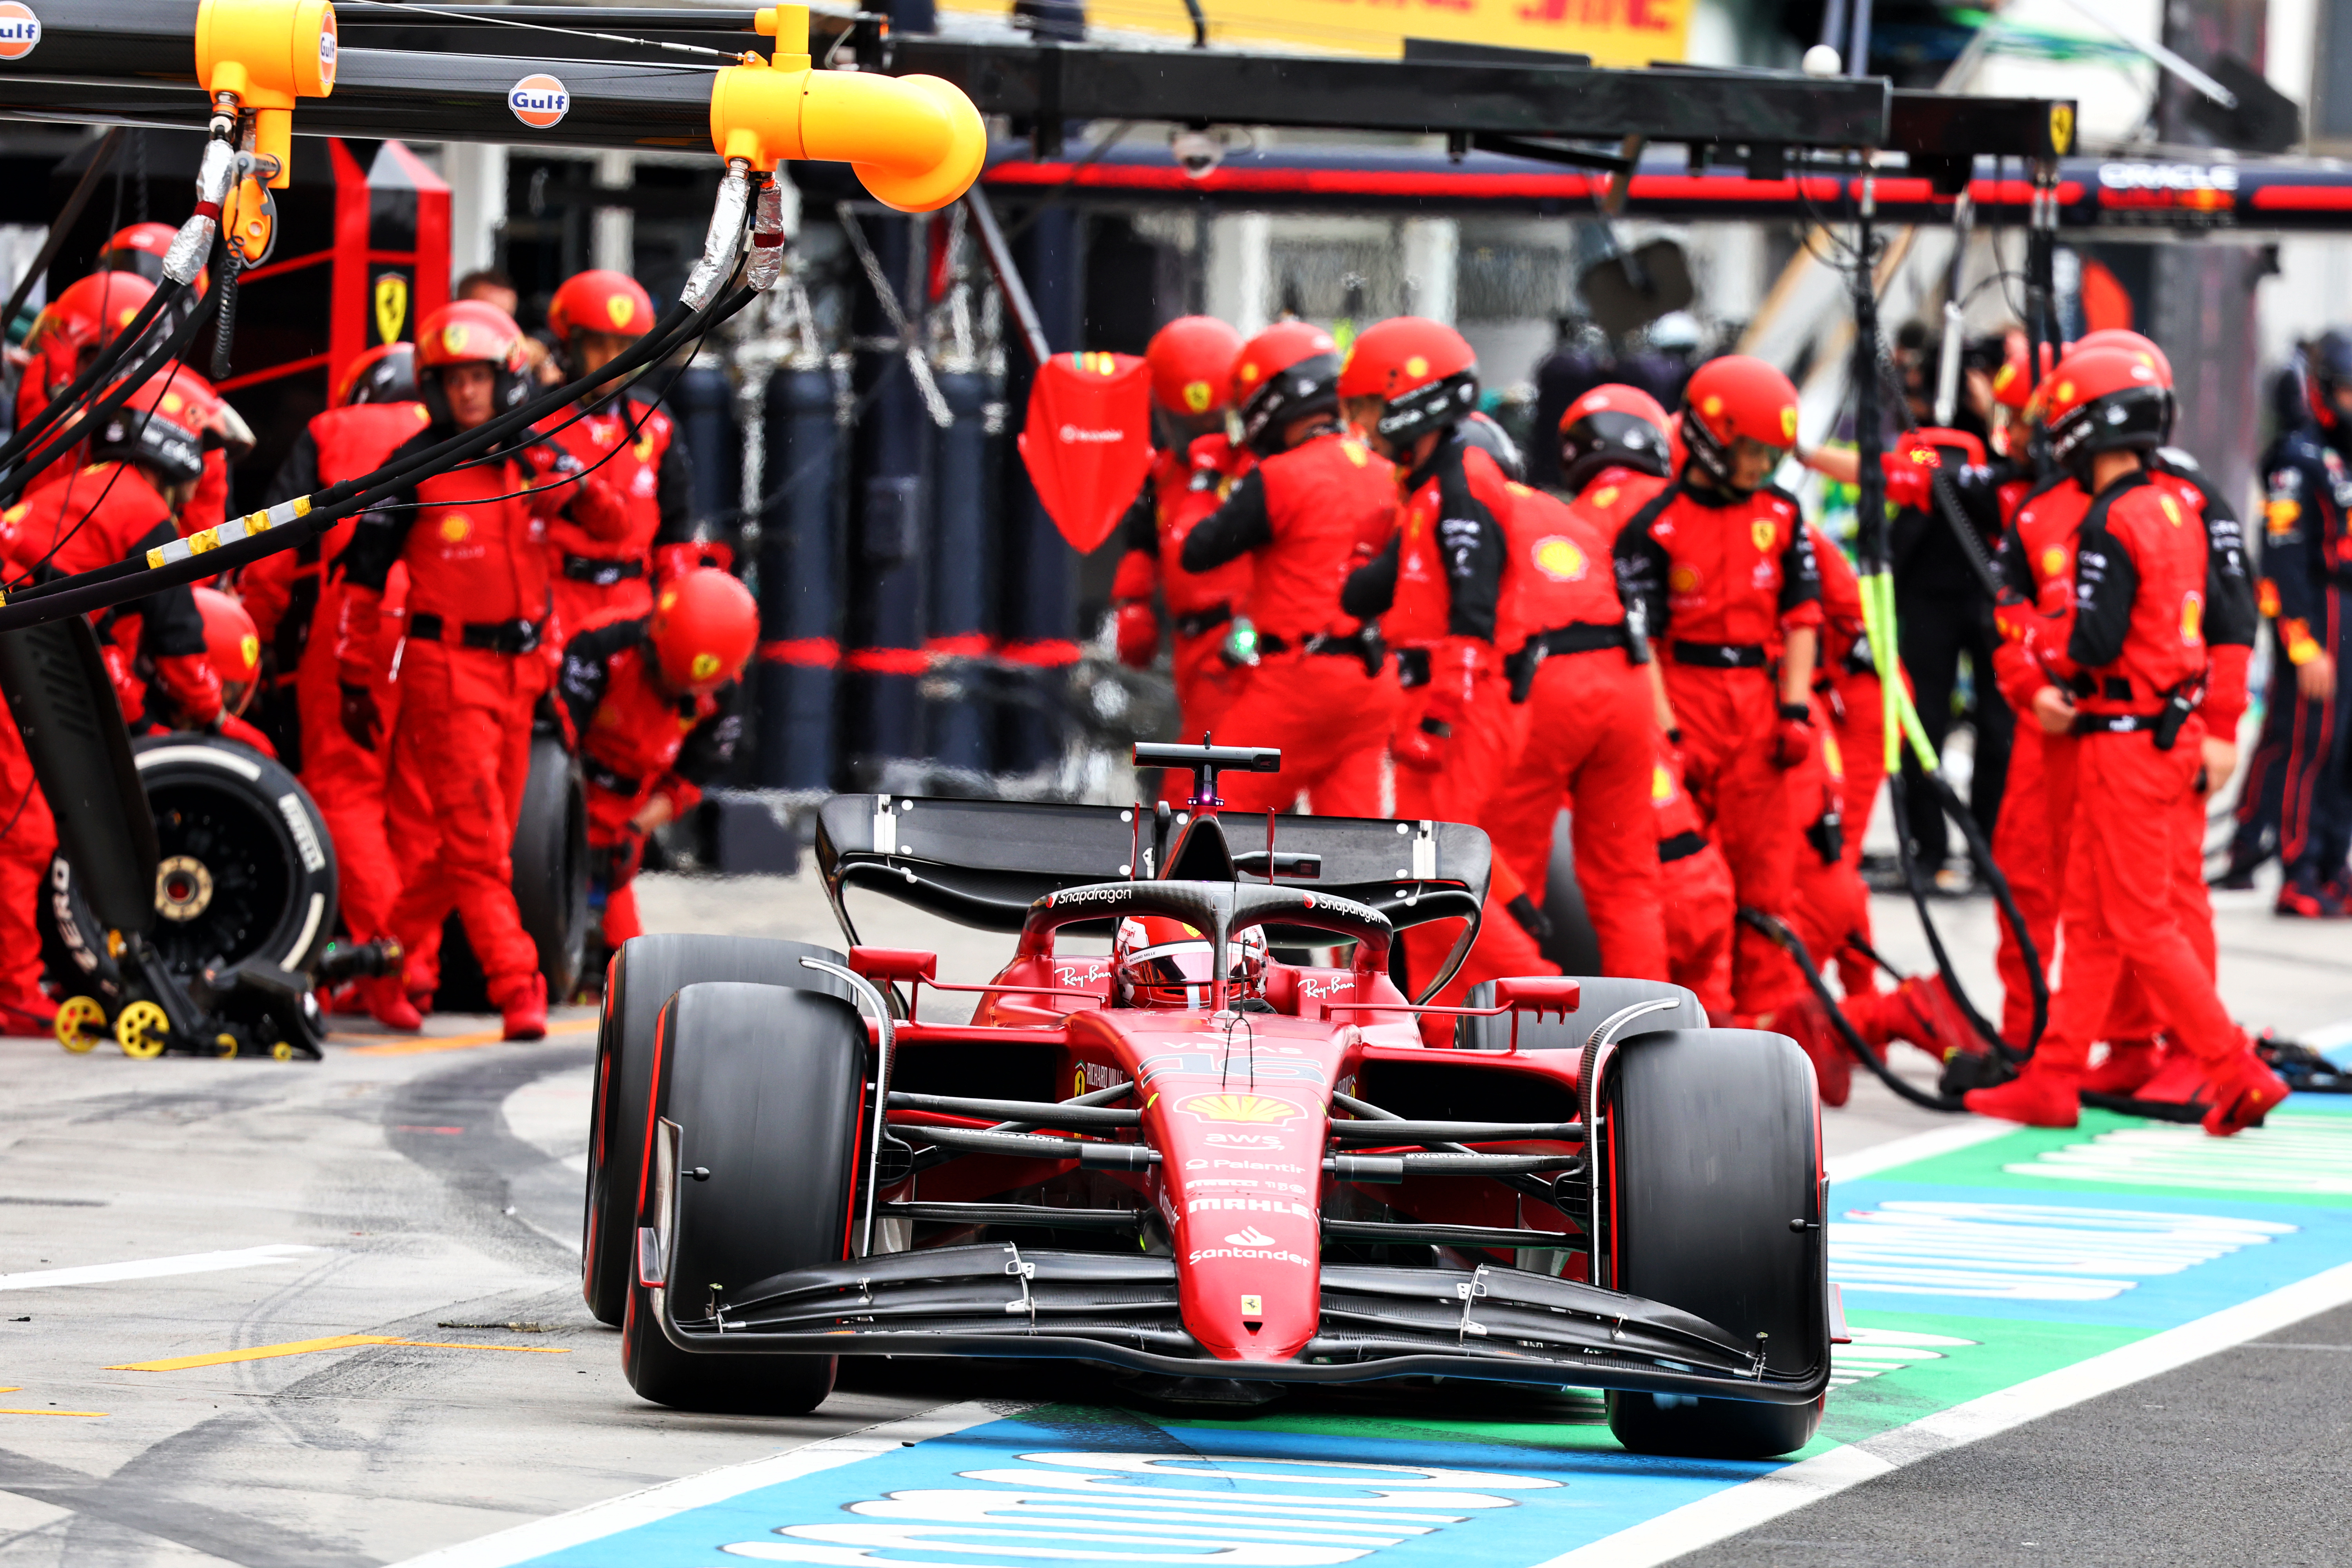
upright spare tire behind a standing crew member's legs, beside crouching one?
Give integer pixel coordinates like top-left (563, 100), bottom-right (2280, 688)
top-left (433, 733), bottom-right (588, 1013)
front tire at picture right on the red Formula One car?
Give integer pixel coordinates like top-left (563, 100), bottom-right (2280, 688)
top-left (1602, 1030), bottom-right (1830, 1460)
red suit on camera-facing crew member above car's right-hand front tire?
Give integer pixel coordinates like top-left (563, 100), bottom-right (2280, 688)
top-left (1616, 479), bottom-right (1820, 1013)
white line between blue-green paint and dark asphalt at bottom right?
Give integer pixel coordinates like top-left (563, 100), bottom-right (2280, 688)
top-left (1536, 1262), bottom-right (2352, 1568)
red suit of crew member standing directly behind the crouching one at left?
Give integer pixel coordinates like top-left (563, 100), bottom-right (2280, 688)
top-left (543, 395), bottom-right (694, 637)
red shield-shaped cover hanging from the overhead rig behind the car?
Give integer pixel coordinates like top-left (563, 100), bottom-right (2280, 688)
top-left (1021, 355), bottom-right (1152, 555)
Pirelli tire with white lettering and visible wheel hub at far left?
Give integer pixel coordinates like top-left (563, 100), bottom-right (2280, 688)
top-left (47, 733), bottom-right (334, 997)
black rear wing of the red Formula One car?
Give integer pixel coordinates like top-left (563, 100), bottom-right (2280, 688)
top-left (816, 795), bottom-right (1491, 943)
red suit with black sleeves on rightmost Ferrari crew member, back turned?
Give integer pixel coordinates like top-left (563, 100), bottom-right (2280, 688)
top-left (2034, 472), bottom-right (2253, 1072)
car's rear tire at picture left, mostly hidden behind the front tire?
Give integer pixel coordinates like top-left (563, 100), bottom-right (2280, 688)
top-left (581, 933), bottom-right (851, 1326)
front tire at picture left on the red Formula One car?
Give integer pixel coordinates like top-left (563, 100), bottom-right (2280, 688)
top-left (621, 983), bottom-right (870, 1415)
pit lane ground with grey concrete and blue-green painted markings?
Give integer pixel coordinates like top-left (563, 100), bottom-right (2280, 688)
top-left (0, 884), bottom-right (2352, 1568)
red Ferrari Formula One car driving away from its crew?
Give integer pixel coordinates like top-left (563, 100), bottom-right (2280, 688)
top-left (583, 748), bottom-right (1835, 1455)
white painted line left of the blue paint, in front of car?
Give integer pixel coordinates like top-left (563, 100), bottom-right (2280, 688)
top-left (393, 1401), bottom-right (1035, 1568)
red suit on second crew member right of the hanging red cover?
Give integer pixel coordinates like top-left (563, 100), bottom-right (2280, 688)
top-left (1178, 428), bottom-right (1397, 816)
